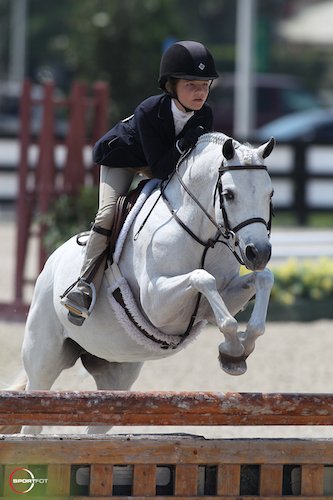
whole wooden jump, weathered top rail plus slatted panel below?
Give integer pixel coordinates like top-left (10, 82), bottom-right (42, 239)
top-left (0, 391), bottom-right (333, 500)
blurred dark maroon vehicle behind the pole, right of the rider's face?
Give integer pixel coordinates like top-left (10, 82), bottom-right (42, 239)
top-left (209, 73), bottom-right (322, 135)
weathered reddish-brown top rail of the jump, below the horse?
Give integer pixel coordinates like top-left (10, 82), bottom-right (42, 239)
top-left (0, 391), bottom-right (333, 426)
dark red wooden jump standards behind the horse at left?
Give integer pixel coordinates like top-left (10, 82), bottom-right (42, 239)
top-left (12, 81), bottom-right (108, 310)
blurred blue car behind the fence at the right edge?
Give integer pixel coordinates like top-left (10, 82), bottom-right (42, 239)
top-left (251, 108), bottom-right (333, 144)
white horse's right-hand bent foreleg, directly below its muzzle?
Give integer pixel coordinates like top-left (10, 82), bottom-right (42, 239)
top-left (237, 268), bottom-right (274, 356)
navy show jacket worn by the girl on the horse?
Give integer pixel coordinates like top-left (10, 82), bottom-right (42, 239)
top-left (93, 94), bottom-right (213, 179)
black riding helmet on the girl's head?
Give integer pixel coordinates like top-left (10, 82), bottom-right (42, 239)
top-left (158, 41), bottom-right (218, 91)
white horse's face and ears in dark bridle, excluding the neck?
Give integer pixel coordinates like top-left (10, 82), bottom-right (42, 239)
top-left (215, 135), bottom-right (275, 270)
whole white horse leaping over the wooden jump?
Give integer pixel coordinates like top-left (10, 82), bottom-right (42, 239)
top-left (3, 133), bottom-right (274, 432)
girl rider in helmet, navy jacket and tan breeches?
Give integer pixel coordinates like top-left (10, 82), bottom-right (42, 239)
top-left (61, 41), bottom-right (218, 326)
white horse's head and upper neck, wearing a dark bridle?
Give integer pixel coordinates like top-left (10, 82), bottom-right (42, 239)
top-left (167, 133), bottom-right (275, 270)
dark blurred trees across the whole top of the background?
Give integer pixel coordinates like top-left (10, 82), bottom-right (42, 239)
top-left (0, 0), bottom-right (327, 124)
